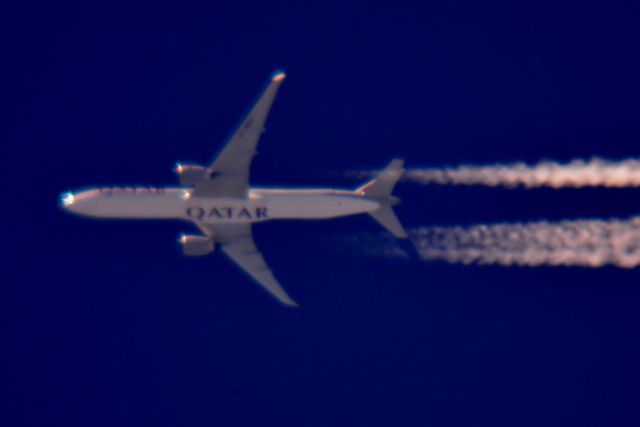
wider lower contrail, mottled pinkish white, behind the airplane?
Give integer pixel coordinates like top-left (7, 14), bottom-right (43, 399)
top-left (344, 216), bottom-right (640, 268)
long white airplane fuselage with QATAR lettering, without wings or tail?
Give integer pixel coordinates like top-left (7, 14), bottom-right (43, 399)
top-left (62, 188), bottom-right (380, 223)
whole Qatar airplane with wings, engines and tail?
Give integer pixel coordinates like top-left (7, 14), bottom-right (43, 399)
top-left (61, 72), bottom-right (407, 307)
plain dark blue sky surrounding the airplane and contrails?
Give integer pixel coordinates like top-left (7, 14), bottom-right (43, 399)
top-left (5, 1), bottom-right (640, 426)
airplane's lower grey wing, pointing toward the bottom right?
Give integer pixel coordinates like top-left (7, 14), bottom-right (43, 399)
top-left (196, 223), bottom-right (298, 307)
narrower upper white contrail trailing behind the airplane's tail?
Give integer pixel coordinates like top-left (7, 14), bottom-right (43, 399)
top-left (404, 158), bottom-right (640, 188)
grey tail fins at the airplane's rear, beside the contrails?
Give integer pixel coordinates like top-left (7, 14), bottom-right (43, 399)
top-left (356, 159), bottom-right (408, 239)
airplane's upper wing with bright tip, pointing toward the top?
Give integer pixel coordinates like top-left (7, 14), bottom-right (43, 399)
top-left (191, 72), bottom-right (285, 197)
